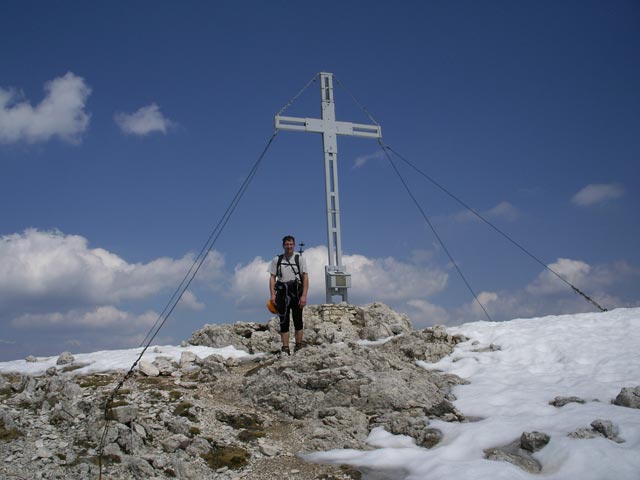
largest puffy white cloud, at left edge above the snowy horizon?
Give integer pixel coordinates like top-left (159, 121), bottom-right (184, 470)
top-left (0, 229), bottom-right (224, 313)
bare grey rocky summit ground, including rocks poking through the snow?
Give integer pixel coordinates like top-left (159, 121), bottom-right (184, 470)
top-left (0, 303), bottom-right (640, 480)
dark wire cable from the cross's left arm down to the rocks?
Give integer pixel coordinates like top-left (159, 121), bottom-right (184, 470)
top-left (98, 130), bottom-right (278, 479)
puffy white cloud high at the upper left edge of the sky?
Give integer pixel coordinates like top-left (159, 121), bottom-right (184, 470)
top-left (0, 72), bottom-right (91, 143)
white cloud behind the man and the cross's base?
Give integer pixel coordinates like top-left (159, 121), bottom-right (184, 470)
top-left (231, 246), bottom-right (448, 307)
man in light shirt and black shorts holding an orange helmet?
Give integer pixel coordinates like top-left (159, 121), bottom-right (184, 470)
top-left (268, 235), bottom-right (309, 355)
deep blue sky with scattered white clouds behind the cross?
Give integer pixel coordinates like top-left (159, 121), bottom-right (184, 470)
top-left (0, 1), bottom-right (640, 360)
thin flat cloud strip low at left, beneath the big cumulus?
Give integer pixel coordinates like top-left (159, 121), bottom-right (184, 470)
top-left (11, 306), bottom-right (158, 331)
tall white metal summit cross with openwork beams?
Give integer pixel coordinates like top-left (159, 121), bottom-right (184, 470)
top-left (275, 72), bottom-right (382, 303)
